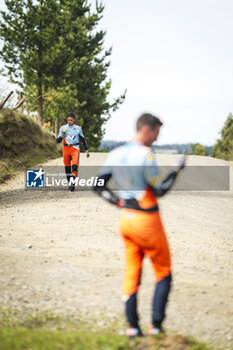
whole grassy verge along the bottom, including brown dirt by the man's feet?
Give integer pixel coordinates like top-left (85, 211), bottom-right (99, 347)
top-left (0, 310), bottom-right (213, 350)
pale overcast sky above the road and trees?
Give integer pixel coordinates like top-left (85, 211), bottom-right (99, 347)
top-left (0, 0), bottom-right (233, 145)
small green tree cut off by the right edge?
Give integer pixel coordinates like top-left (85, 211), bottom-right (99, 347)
top-left (211, 113), bottom-right (233, 160)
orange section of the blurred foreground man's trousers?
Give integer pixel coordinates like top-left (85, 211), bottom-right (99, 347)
top-left (120, 209), bottom-right (171, 296)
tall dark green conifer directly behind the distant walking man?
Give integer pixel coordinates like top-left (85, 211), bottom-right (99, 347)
top-left (41, 0), bottom-right (125, 148)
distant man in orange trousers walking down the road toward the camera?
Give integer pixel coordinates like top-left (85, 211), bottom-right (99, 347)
top-left (57, 113), bottom-right (90, 191)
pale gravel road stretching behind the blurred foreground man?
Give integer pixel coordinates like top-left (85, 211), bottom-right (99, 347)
top-left (0, 154), bottom-right (233, 349)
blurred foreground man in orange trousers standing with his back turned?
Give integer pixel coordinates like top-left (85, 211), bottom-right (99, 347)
top-left (94, 114), bottom-right (184, 337)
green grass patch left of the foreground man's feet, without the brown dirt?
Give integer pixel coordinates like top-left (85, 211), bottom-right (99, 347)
top-left (0, 309), bottom-right (133, 350)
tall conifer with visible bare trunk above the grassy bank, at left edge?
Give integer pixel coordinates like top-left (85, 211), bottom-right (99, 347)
top-left (0, 0), bottom-right (67, 124)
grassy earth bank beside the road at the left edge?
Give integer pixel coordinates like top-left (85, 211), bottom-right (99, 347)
top-left (0, 109), bottom-right (61, 183)
